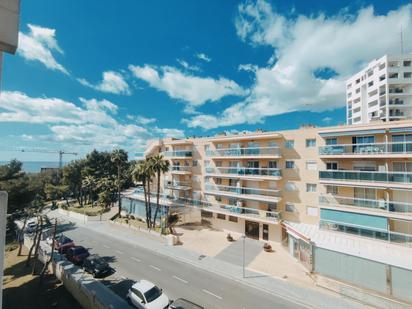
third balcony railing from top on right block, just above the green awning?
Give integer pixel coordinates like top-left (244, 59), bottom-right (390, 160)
top-left (319, 195), bottom-right (412, 215)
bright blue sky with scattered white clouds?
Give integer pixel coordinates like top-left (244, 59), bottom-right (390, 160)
top-left (0, 0), bottom-right (412, 161)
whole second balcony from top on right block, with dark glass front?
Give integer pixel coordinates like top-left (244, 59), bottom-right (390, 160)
top-left (319, 170), bottom-right (412, 189)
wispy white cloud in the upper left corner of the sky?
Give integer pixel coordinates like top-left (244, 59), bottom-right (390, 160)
top-left (17, 24), bottom-right (69, 75)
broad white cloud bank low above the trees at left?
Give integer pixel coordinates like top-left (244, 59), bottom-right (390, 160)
top-left (0, 91), bottom-right (184, 151)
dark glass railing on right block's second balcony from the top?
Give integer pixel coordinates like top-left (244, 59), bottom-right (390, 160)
top-left (319, 170), bottom-right (412, 184)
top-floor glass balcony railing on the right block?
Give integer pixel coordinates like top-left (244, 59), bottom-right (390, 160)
top-left (319, 142), bottom-right (412, 156)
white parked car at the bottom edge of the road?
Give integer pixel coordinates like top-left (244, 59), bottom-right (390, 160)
top-left (127, 280), bottom-right (170, 309)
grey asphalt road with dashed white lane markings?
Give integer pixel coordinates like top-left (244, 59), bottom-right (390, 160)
top-left (60, 226), bottom-right (307, 309)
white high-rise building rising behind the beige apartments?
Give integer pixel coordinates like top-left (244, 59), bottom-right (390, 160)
top-left (346, 54), bottom-right (412, 124)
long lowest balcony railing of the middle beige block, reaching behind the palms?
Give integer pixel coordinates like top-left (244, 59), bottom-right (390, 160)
top-left (129, 189), bottom-right (281, 222)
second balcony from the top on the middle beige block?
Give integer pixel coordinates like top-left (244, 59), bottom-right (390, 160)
top-left (206, 167), bottom-right (281, 180)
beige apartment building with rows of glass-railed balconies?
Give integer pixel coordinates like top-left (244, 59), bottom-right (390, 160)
top-left (125, 120), bottom-right (412, 254)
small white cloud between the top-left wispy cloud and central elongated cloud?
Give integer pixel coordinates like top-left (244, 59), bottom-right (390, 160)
top-left (77, 71), bottom-right (130, 95)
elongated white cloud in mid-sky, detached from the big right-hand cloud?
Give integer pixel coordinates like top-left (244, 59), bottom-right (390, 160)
top-left (129, 65), bottom-right (247, 110)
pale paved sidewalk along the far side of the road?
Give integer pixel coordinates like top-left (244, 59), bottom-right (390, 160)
top-left (51, 209), bottom-right (368, 309)
